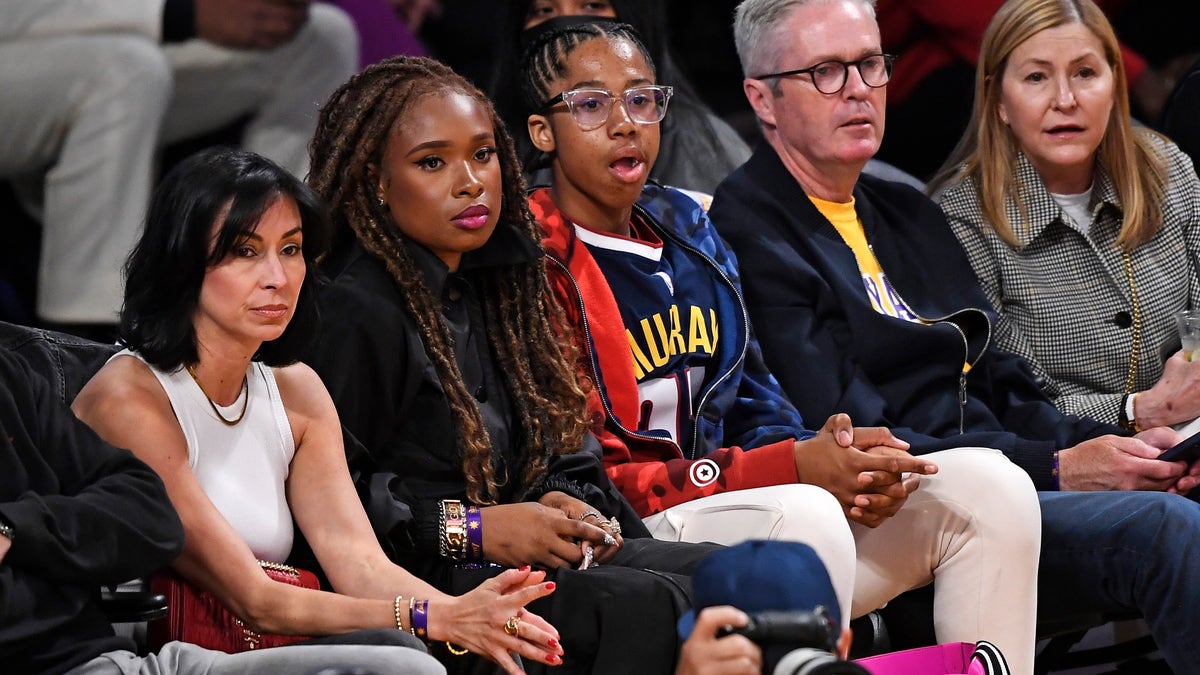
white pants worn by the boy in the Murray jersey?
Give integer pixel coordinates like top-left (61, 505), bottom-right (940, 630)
top-left (644, 448), bottom-right (1042, 674)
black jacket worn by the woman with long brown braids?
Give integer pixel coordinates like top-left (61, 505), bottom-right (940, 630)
top-left (305, 227), bottom-right (648, 583)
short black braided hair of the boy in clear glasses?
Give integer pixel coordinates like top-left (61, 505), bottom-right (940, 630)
top-left (521, 22), bottom-right (656, 123)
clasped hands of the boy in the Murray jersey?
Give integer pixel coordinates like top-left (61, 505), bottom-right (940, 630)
top-left (796, 413), bottom-right (937, 527)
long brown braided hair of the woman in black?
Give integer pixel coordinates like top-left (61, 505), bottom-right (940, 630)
top-left (308, 56), bottom-right (588, 504)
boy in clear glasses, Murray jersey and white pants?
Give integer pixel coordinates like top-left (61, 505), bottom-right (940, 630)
top-left (523, 24), bottom-right (1038, 659)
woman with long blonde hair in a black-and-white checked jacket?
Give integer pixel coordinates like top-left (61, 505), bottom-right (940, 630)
top-left (930, 0), bottom-right (1200, 429)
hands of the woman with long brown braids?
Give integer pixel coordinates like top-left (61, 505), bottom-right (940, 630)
top-left (479, 491), bottom-right (624, 569)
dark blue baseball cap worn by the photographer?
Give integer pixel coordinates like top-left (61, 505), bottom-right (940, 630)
top-left (678, 540), bottom-right (841, 640)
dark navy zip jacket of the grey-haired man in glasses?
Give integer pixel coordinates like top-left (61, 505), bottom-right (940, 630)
top-left (709, 144), bottom-right (1122, 489)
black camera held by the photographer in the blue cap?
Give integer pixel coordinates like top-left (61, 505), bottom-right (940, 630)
top-left (716, 607), bottom-right (866, 675)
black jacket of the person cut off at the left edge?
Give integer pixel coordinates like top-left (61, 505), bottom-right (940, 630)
top-left (0, 324), bottom-right (184, 673)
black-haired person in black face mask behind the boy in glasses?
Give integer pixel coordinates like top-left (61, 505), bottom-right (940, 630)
top-left (488, 0), bottom-right (750, 193)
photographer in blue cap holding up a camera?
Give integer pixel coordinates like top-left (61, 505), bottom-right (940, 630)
top-left (676, 540), bottom-right (868, 675)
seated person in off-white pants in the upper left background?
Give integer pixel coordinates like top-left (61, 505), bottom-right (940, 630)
top-left (0, 0), bottom-right (358, 333)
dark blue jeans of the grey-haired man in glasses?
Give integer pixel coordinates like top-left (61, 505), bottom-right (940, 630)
top-left (1038, 491), bottom-right (1200, 673)
